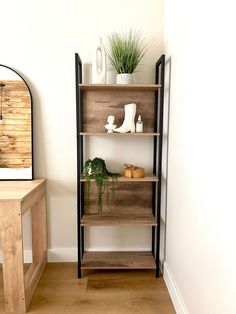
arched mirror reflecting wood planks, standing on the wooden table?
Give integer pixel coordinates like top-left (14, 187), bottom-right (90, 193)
top-left (0, 64), bottom-right (33, 180)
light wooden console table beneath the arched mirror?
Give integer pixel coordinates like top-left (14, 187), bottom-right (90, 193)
top-left (0, 179), bottom-right (47, 313)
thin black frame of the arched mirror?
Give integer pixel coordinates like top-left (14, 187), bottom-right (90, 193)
top-left (0, 64), bottom-right (34, 181)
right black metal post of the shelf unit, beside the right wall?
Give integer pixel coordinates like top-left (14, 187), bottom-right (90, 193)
top-left (156, 55), bottom-right (165, 277)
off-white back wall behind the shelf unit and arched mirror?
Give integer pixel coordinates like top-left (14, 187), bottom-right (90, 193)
top-left (0, 0), bottom-right (163, 259)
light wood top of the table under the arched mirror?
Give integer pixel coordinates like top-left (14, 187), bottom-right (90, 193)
top-left (0, 179), bottom-right (46, 201)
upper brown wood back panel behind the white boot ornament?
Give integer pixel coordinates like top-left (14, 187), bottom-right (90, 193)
top-left (83, 89), bottom-right (155, 133)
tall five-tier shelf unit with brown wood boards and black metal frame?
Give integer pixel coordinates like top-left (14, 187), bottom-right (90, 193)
top-left (75, 53), bottom-right (165, 278)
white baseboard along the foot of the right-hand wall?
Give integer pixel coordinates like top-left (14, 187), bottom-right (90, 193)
top-left (163, 262), bottom-right (189, 314)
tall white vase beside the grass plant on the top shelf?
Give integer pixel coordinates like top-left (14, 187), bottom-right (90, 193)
top-left (92, 38), bottom-right (106, 84)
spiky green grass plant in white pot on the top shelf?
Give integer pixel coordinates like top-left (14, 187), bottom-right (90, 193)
top-left (106, 29), bottom-right (148, 84)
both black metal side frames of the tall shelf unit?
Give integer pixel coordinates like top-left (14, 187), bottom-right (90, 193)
top-left (75, 53), bottom-right (165, 278)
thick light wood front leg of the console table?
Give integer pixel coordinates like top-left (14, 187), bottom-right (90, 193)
top-left (0, 201), bottom-right (26, 313)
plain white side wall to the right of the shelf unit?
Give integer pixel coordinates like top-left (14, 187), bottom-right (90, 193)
top-left (165, 0), bottom-right (236, 314)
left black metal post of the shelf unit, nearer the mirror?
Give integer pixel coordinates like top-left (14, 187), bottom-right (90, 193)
top-left (75, 53), bottom-right (84, 278)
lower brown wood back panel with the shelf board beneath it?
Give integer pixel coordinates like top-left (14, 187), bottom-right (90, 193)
top-left (81, 174), bottom-right (157, 227)
